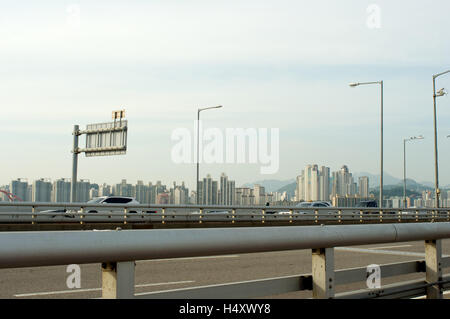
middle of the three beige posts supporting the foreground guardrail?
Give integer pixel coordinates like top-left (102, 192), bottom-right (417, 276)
top-left (312, 248), bottom-right (334, 299)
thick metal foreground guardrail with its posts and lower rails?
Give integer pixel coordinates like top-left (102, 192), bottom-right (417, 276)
top-left (0, 222), bottom-right (450, 299)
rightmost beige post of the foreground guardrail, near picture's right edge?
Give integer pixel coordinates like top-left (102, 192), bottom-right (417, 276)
top-left (425, 239), bottom-right (443, 299)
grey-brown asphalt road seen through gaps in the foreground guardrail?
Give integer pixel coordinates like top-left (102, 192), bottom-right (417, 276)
top-left (0, 239), bottom-right (450, 299)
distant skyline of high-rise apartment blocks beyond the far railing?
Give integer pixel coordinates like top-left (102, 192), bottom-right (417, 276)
top-left (4, 168), bottom-right (450, 208)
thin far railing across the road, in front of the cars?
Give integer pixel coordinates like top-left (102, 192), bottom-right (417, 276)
top-left (0, 202), bottom-right (450, 224)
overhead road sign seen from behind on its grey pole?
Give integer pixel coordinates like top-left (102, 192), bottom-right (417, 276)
top-left (70, 110), bottom-right (128, 202)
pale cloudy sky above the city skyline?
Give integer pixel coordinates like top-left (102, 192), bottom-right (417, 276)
top-left (0, 0), bottom-right (450, 187)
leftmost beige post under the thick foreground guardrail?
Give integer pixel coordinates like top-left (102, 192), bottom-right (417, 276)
top-left (102, 261), bottom-right (135, 299)
